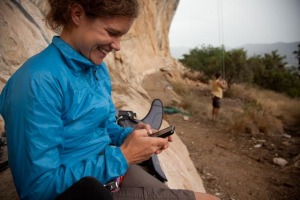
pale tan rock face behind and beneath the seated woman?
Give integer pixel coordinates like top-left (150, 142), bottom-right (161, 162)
top-left (0, 0), bottom-right (205, 197)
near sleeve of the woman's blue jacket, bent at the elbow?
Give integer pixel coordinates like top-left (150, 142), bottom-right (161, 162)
top-left (4, 74), bottom-right (128, 199)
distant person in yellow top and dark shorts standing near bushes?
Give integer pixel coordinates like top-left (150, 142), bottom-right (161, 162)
top-left (211, 72), bottom-right (227, 120)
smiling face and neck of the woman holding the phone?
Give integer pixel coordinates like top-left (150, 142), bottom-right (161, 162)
top-left (61, 5), bottom-right (133, 65)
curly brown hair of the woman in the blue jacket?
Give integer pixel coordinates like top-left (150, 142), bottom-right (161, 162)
top-left (46, 0), bottom-right (139, 30)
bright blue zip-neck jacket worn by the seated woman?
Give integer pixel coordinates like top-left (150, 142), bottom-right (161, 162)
top-left (0, 36), bottom-right (132, 200)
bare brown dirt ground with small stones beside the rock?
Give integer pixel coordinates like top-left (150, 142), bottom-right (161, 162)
top-left (143, 73), bottom-right (300, 200)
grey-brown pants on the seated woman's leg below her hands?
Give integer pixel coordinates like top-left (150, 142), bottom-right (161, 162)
top-left (113, 165), bottom-right (195, 200)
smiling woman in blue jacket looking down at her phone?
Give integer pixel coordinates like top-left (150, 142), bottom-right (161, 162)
top-left (0, 0), bottom-right (218, 199)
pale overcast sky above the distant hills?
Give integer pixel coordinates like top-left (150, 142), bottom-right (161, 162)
top-left (169, 0), bottom-right (300, 56)
